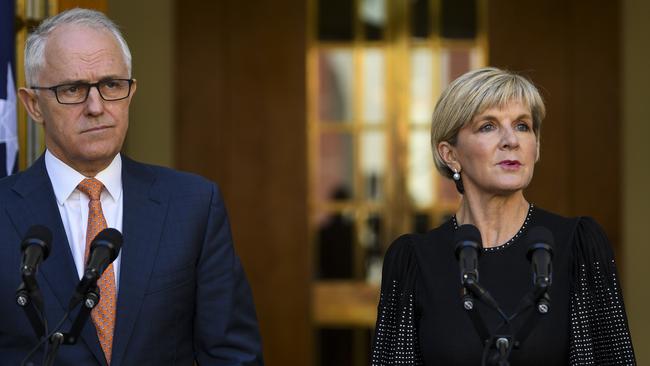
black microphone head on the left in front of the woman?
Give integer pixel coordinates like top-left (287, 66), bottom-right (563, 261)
top-left (454, 224), bottom-right (483, 285)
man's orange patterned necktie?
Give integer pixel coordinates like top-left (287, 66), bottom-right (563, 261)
top-left (77, 178), bottom-right (117, 365)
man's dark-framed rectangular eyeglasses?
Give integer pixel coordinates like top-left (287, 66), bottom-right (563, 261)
top-left (30, 79), bottom-right (133, 104)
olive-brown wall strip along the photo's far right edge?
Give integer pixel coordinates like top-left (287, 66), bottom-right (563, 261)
top-left (622, 0), bottom-right (650, 365)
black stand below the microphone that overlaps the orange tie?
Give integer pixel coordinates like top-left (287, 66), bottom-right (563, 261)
top-left (43, 283), bottom-right (99, 366)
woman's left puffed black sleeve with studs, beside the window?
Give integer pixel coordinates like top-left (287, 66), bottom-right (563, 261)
top-left (371, 235), bottom-right (423, 366)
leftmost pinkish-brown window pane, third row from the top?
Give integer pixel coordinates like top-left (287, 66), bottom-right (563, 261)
top-left (317, 132), bottom-right (354, 201)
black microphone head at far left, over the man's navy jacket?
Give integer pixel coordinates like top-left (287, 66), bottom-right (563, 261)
top-left (20, 225), bottom-right (52, 286)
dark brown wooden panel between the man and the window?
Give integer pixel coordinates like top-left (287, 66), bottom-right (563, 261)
top-left (176, 0), bottom-right (311, 366)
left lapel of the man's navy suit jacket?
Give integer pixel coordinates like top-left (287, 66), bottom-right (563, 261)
top-left (7, 156), bottom-right (106, 365)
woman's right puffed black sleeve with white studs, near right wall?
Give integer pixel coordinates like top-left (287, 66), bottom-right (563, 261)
top-left (569, 217), bottom-right (636, 365)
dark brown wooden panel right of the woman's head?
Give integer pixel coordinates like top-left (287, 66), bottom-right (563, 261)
top-left (488, 0), bottom-right (621, 252)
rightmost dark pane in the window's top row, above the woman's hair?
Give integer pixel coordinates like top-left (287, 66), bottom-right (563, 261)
top-left (440, 0), bottom-right (476, 39)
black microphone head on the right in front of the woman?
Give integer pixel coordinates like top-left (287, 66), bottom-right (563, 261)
top-left (526, 226), bottom-right (553, 289)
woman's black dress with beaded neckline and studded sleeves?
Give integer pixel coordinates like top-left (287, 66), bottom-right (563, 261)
top-left (372, 205), bottom-right (635, 366)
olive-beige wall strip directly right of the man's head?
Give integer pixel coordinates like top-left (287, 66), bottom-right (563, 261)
top-left (108, 0), bottom-right (175, 167)
